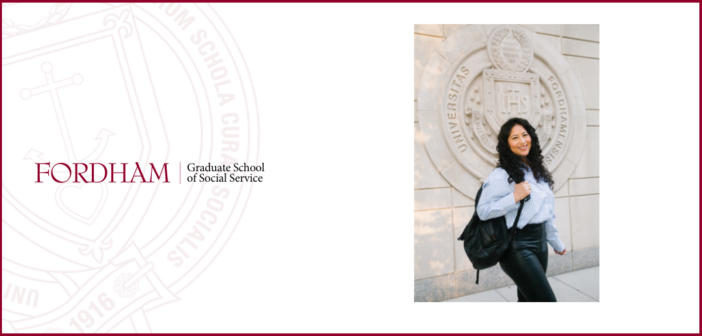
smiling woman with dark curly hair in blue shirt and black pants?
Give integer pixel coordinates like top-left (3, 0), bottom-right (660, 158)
top-left (477, 118), bottom-right (566, 302)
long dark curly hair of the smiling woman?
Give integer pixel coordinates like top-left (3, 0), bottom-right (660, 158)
top-left (497, 118), bottom-right (553, 190)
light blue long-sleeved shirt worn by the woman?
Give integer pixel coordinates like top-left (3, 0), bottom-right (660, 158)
top-left (477, 167), bottom-right (565, 252)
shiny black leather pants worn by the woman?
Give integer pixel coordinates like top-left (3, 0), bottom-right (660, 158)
top-left (500, 223), bottom-right (556, 302)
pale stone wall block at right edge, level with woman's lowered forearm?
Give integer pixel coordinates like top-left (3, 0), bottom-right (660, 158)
top-left (568, 195), bottom-right (600, 251)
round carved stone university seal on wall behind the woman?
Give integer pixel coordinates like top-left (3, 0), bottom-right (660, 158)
top-left (417, 25), bottom-right (586, 198)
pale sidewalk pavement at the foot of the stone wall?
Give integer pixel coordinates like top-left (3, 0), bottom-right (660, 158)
top-left (444, 266), bottom-right (600, 302)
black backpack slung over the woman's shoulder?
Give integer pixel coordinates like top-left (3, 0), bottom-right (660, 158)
top-left (458, 185), bottom-right (530, 284)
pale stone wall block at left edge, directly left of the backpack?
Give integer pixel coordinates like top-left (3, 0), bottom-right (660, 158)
top-left (414, 210), bottom-right (456, 278)
